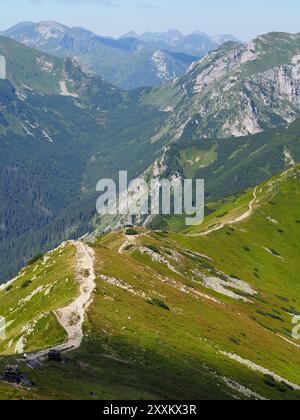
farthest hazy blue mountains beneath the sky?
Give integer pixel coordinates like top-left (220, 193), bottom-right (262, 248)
top-left (4, 22), bottom-right (202, 90)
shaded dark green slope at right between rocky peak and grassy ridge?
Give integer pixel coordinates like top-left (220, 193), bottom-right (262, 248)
top-left (151, 118), bottom-right (300, 209)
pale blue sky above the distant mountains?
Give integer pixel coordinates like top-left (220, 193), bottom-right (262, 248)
top-left (0, 0), bottom-right (300, 40)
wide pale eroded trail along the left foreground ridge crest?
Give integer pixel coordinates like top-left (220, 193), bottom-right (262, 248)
top-left (55, 242), bottom-right (96, 350)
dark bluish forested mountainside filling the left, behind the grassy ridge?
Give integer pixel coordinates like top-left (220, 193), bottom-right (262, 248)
top-left (0, 37), bottom-right (164, 280)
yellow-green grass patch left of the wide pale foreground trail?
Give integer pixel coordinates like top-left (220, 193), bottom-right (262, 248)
top-left (0, 245), bottom-right (79, 354)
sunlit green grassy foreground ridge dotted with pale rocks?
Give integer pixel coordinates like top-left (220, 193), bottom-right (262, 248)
top-left (0, 166), bottom-right (300, 399)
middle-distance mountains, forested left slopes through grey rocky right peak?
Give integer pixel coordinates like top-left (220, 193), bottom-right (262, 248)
top-left (0, 33), bottom-right (300, 280)
